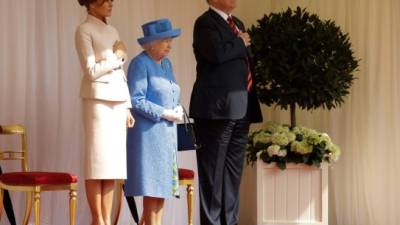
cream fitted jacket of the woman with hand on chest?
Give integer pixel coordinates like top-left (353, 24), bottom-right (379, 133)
top-left (75, 15), bottom-right (131, 105)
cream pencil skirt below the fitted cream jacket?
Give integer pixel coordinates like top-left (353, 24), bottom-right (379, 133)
top-left (82, 99), bottom-right (127, 180)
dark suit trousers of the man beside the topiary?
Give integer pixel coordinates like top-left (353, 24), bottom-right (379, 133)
top-left (195, 118), bottom-right (250, 225)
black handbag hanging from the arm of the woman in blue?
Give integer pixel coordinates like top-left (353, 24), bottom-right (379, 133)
top-left (177, 107), bottom-right (199, 151)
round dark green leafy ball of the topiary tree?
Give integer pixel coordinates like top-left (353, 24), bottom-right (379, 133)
top-left (249, 7), bottom-right (358, 112)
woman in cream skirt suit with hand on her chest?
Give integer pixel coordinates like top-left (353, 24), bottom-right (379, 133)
top-left (75, 0), bottom-right (134, 225)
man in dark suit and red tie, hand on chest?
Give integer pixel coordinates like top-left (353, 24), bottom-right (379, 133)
top-left (190, 0), bottom-right (262, 225)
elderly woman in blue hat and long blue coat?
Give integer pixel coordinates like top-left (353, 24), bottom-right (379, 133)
top-left (125, 19), bottom-right (183, 225)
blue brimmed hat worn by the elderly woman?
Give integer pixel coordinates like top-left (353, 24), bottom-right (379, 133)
top-left (138, 19), bottom-right (181, 45)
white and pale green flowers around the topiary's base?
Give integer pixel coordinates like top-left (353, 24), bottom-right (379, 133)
top-left (247, 122), bottom-right (340, 170)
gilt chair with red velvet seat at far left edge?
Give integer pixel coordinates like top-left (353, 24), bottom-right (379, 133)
top-left (0, 125), bottom-right (78, 225)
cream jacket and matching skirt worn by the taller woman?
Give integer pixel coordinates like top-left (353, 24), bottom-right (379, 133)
top-left (75, 15), bottom-right (131, 179)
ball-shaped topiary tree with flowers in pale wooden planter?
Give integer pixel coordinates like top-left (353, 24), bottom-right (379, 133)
top-left (242, 7), bottom-right (359, 225)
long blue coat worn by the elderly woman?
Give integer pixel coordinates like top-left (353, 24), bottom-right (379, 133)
top-left (125, 52), bottom-right (180, 198)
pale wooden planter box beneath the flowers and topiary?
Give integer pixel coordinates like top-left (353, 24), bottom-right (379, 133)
top-left (240, 160), bottom-right (328, 225)
